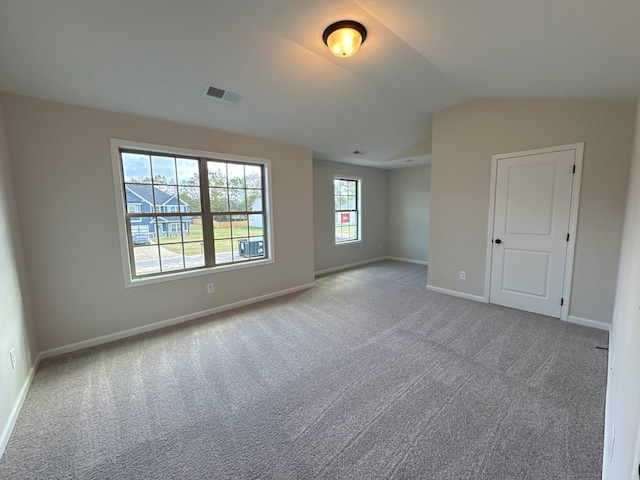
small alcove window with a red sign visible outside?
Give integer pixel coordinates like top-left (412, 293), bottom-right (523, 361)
top-left (333, 177), bottom-right (361, 244)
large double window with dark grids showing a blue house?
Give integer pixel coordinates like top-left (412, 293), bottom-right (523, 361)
top-left (119, 148), bottom-right (268, 279)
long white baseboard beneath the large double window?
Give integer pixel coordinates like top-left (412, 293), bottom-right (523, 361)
top-left (40, 282), bottom-right (315, 358)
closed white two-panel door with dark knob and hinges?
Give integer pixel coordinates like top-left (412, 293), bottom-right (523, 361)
top-left (489, 149), bottom-right (576, 318)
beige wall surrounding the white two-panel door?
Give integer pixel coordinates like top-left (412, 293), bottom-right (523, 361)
top-left (428, 100), bottom-right (635, 323)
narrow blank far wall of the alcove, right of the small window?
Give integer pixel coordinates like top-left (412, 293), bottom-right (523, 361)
top-left (387, 165), bottom-right (431, 262)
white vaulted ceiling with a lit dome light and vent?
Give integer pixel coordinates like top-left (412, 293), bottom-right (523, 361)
top-left (0, 0), bottom-right (640, 168)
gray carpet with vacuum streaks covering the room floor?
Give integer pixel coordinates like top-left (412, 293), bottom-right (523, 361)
top-left (0, 261), bottom-right (608, 480)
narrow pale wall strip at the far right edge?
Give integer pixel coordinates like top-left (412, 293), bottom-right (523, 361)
top-left (602, 98), bottom-right (640, 480)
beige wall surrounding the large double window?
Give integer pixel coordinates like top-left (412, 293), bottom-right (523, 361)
top-left (2, 94), bottom-right (314, 350)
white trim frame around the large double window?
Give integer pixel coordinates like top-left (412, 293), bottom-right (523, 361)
top-left (109, 138), bottom-right (275, 288)
